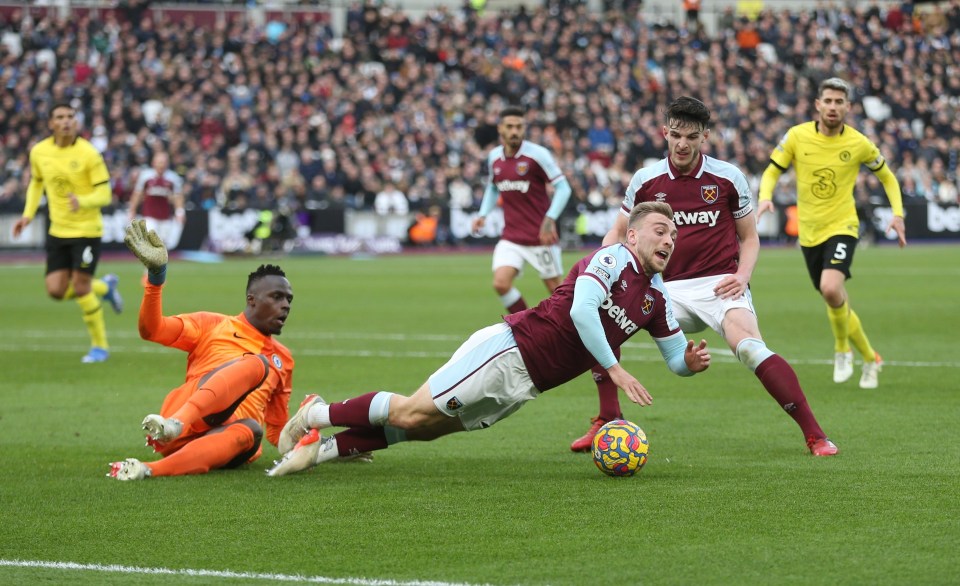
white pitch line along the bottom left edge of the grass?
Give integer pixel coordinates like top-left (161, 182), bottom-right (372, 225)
top-left (0, 559), bottom-right (489, 586)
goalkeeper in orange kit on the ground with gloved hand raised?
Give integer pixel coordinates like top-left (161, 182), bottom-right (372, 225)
top-left (108, 220), bottom-right (293, 480)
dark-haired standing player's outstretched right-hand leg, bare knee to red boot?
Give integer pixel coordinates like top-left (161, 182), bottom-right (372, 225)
top-left (722, 307), bottom-right (837, 456)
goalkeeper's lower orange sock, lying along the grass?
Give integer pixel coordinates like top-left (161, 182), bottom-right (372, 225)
top-left (147, 423), bottom-right (255, 476)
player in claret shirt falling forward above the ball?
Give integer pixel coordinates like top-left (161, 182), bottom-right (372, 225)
top-left (268, 203), bottom-right (710, 476)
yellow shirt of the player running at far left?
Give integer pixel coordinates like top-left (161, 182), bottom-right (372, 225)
top-left (23, 136), bottom-right (111, 238)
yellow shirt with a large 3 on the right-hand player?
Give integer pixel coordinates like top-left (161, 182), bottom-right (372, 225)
top-left (770, 122), bottom-right (885, 246)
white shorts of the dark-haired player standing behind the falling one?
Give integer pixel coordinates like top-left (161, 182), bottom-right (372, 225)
top-left (667, 275), bottom-right (757, 336)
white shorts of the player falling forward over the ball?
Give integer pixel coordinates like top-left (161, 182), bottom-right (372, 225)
top-left (427, 323), bottom-right (540, 431)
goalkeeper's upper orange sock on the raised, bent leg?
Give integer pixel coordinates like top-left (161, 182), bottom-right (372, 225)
top-left (170, 354), bottom-right (270, 429)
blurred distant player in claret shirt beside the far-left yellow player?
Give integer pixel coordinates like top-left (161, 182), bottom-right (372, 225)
top-left (127, 151), bottom-right (186, 250)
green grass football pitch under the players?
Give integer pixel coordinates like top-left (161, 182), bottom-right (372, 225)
top-left (0, 245), bottom-right (960, 586)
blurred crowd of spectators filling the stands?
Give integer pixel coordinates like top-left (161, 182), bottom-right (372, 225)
top-left (0, 0), bottom-right (960, 234)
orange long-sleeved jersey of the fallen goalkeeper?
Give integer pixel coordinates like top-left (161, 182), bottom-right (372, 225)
top-left (139, 284), bottom-right (293, 445)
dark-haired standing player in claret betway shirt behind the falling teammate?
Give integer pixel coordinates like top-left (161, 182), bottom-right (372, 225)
top-left (604, 97), bottom-right (838, 456)
